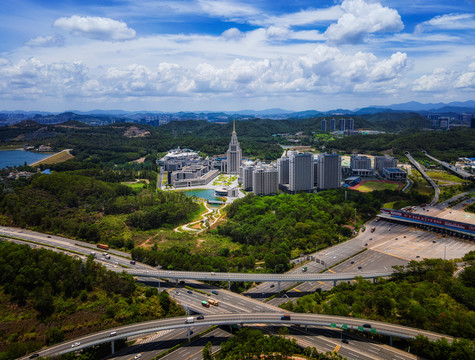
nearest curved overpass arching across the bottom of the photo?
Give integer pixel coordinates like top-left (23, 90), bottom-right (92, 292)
top-left (24, 313), bottom-right (453, 359)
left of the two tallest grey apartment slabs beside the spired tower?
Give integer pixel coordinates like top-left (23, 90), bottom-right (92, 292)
top-left (289, 153), bottom-right (313, 194)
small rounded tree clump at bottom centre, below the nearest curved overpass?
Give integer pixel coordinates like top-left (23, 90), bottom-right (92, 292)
top-left (208, 328), bottom-right (343, 360)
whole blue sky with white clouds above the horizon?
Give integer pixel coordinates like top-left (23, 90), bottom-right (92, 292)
top-left (0, 0), bottom-right (475, 111)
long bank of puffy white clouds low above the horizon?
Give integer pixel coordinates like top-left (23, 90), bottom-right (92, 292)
top-left (0, 45), bottom-right (407, 100)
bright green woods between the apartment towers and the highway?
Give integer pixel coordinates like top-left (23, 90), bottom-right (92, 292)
top-left (132, 190), bottom-right (424, 272)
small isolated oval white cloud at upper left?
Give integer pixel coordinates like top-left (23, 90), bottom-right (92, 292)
top-left (54, 15), bottom-right (135, 41)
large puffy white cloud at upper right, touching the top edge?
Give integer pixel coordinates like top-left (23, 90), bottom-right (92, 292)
top-left (325, 0), bottom-right (404, 43)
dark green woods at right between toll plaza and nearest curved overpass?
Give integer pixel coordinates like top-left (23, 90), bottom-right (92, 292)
top-left (282, 259), bottom-right (475, 358)
